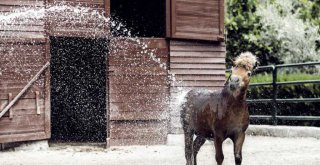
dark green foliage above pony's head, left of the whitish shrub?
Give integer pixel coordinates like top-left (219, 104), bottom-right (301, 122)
top-left (225, 0), bottom-right (278, 66)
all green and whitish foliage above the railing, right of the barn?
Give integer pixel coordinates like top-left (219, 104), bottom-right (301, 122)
top-left (225, 0), bottom-right (320, 66)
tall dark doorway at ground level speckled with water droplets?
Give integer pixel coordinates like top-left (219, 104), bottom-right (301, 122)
top-left (50, 37), bottom-right (108, 142)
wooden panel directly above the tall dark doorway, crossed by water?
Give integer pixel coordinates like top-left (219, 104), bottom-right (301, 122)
top-left (47, 0), bottom-right (110, 38)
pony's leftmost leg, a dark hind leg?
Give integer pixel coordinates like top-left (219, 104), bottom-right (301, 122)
top-left (184, 131), bottom-right (193, 165)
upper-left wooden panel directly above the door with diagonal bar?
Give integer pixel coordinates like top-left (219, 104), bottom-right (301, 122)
top-left (0, 0), bottom-right (45, 42)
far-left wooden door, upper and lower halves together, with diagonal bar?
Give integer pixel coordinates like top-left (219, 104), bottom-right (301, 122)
top-left (0, 0), bottom-right (50, 143)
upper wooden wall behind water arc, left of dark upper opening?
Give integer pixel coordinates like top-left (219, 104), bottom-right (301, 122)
top-left (0, 0), bottom-right (110, 38)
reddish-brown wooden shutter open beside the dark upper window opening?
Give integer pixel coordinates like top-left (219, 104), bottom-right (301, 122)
top-left (171, 0), bottom-right (224, 41)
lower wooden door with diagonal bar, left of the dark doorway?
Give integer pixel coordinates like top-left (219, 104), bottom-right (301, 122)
top-left (0, 42), bottom-right (50, 143)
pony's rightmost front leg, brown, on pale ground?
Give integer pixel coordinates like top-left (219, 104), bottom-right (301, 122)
top-left (232, 132), bottom-right (245, 165)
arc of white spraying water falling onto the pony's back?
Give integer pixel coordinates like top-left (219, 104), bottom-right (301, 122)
top-left (0, 3), bottom-right (186, 142)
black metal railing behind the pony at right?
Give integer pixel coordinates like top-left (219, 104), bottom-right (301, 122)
top-left (227, 62), bottom-right (320, 125)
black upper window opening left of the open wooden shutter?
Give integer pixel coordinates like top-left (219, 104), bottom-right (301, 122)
top-left (110, 0), bottom-right (166, 37)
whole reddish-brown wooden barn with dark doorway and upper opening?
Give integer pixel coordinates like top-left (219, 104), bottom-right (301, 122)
top-left (0, 0), bottom-right (226, 146)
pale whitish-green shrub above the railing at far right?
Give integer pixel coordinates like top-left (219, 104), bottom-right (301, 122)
top-left (256, 0), bottom-right (320, 63)
